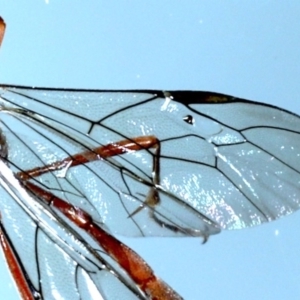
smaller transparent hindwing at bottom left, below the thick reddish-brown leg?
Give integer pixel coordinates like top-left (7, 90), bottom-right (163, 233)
top-left (0, 154), bottom-right (148, 299)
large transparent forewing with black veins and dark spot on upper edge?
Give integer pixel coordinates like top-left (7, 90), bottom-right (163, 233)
top-left (2, 87), bottom-right (300, 236)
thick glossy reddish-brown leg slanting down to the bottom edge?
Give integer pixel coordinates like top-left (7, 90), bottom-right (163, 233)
top-left (23, 181), bottom-right (182, 300)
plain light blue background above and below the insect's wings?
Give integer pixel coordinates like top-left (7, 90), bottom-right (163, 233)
top-left (0, 0), bottom-right (300, 300)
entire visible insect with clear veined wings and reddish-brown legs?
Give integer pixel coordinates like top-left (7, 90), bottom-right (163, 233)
top-left (0, 15), bottom-right (300, 299)
